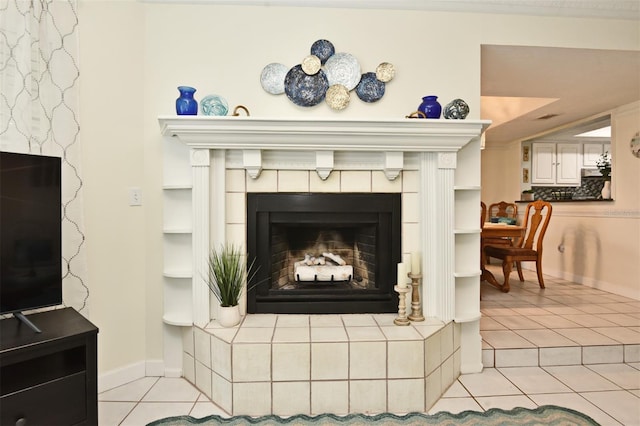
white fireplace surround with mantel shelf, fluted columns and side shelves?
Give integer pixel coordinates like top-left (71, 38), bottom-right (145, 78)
top-left (158, 116), bottom-right (490, 372)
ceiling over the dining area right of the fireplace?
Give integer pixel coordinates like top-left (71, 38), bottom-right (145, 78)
top-left (481, 46), bottom-right (640, 147)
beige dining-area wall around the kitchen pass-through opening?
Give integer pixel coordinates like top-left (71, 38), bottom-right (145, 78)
top-left (482, 103), bottom-right (640, 299)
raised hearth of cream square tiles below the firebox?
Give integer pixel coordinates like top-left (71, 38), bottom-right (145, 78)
top-left (183, 314), bottom-right (460, 415)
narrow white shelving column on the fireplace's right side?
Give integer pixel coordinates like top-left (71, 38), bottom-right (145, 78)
top-left (454, 137), bottom-right (482, 374)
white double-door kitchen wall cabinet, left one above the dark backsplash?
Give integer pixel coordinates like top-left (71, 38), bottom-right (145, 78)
top-left (531, 142), bottom-right (581, 186)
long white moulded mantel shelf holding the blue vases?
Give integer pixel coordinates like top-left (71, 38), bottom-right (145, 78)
top-left (159, 116), bottom-right (490, 152)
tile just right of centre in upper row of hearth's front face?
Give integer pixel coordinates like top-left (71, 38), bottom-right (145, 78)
top-left (349, 342), bottom-right (387, 380)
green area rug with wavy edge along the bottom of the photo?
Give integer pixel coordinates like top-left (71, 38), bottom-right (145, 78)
top-left (147, 405), bottom-right (599, 426)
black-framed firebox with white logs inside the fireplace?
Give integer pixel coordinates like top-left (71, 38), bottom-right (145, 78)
top-left (247, 193), bottom-right (401, 314)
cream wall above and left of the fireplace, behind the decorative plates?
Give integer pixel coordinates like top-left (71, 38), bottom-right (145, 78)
top-left (79, 0), bottom-right (640, 376)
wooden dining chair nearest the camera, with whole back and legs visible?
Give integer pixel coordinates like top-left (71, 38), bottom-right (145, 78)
top-left (483, 200), bottom-right (552, 292)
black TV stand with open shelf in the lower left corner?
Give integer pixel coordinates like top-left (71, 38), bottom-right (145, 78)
top-left (0, 308), bottom-right (98, 426)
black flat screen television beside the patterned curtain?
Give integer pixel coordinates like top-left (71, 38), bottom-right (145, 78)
top-left (0, 151), bottom-right (62, 331)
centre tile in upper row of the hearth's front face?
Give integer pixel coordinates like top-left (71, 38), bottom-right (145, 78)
top-left (311, 342), bottom-right (349, 380)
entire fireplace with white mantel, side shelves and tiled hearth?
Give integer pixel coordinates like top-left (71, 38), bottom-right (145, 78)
top-left (159, 116), bottom-right (489, 414)
